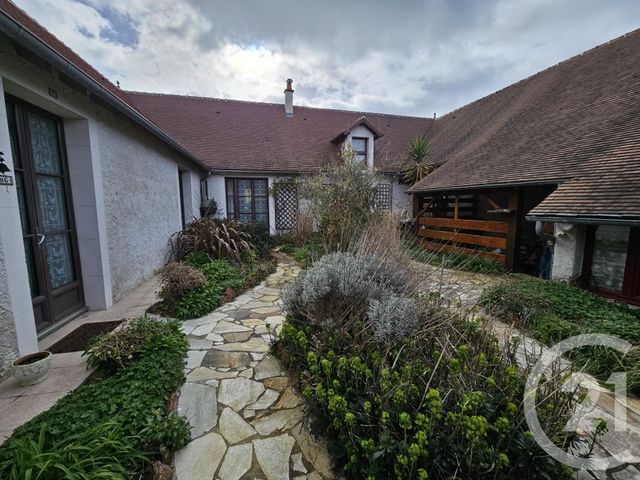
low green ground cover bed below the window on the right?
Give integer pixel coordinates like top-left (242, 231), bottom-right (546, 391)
top-left (481, 276), bottom-right (640, 395)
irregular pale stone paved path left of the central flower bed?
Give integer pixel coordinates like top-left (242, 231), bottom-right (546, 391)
top-left (174, 256), bottom-right (332, 480)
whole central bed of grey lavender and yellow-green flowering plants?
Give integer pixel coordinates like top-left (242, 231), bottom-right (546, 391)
top-left (274, 221), bottom-right (577, 479)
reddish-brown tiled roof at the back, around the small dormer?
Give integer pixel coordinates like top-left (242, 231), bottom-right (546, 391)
top-left (128, 92), bottom-right (433, 173)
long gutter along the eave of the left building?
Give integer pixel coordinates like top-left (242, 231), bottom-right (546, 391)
top-left (0, 12), bottom-right (208, 170)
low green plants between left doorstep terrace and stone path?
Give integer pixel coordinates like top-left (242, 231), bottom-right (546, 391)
top-left (0, 318), bottom-right (190, 480)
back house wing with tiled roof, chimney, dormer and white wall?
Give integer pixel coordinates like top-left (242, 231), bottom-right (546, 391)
top-left (127, 80), bottom-right (433, 233)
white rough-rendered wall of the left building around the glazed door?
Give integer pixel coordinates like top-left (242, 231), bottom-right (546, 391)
top-left (0, 35), bottom-right (202, 326)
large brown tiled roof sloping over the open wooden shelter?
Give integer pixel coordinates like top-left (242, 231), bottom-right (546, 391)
top-left (412, 30), bottom-right (640, 218)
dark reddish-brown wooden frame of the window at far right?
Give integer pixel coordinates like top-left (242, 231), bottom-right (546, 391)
top-left (582, 225), bottom-right (640, 305)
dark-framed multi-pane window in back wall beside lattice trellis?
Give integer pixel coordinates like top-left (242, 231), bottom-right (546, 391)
top-left (226, 178), bottom-right (269, 223)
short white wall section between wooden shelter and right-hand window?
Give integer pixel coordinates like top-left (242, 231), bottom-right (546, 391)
top-left (551, 223), bottom-right (586, 281)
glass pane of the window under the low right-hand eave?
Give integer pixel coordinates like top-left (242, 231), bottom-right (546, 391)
top-left (591, 225), bottom-right (631, 292)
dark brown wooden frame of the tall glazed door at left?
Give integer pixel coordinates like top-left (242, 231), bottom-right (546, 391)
top-left (5, 94), bottom-right (85, 334)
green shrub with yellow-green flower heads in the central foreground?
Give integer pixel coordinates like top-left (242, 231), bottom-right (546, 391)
top-left (276, 318), bottom-right (572, 480)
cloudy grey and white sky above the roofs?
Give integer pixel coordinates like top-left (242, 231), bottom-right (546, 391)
top-left (12, 0), bottom-right (640, 116)
